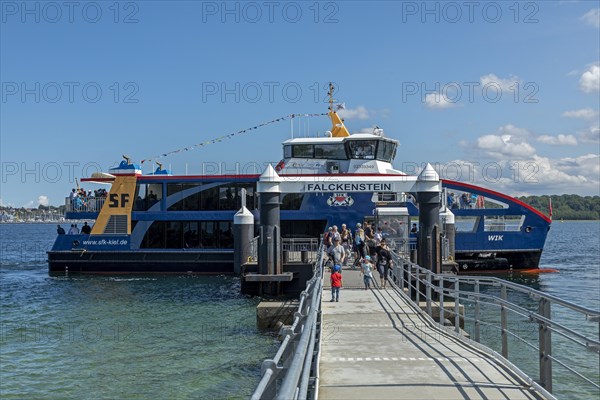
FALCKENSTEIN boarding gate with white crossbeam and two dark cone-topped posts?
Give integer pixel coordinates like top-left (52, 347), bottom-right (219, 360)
top-left (248, 164), bottom-right (443, 287)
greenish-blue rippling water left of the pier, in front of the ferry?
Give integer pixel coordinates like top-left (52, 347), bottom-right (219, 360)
top-left (0, 224), bottom-right (278, 400)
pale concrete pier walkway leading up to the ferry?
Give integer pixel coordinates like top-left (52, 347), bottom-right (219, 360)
top-left (318, 269), bottom-right (544, 400)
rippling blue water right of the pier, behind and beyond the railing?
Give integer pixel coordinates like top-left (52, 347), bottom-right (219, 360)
top-left (465, 221), bottom-right (600, 400)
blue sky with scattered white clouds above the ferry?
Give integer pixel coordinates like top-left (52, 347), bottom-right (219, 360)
top-left (0, 1), bottom-right (600, 206)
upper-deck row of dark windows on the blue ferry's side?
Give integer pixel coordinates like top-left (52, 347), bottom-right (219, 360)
top-left (133, 183), bottom-right (304, 211)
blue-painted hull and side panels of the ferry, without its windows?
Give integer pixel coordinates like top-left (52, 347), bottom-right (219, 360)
top-left (48, 176), bottom-right (551, 274)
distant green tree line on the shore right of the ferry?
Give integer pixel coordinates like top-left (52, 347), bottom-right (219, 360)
top-left (517, 194), bottom-right (600, 220)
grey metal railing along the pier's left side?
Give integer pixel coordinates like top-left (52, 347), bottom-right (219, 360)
top-left (251, 245), bottom-right (326, 400)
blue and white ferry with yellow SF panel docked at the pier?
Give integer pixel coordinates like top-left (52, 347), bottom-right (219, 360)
top-left (48, 99), bottom-right (551, 274)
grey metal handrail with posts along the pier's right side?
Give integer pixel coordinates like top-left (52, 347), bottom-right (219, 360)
top-left (391, 253), bottom-right (600, 393)
